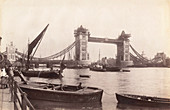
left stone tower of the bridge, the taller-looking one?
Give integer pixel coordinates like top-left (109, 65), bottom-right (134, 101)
top-left (74, 25), bottom-right (90, 65)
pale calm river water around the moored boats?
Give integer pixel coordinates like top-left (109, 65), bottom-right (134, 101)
top-left (23, 68), bottom-right (170, 110)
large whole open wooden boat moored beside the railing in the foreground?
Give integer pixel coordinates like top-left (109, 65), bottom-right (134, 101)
top-left (20, 82), bottom-right (103, 103)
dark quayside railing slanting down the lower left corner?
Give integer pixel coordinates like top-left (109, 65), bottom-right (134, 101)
top-left (7, 68), bottom-right (35, 110)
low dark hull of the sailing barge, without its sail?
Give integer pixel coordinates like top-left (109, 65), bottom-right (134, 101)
top-left (14, 71), bottom-right (62, 78)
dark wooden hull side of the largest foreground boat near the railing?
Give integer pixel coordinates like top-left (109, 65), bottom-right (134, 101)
top-left (20, 82), bottom-right (103, 103)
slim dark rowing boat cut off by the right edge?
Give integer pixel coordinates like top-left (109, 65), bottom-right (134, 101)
top-left (116, 93), bottom-right (170, 106)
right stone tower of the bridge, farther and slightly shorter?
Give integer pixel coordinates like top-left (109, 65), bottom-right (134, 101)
top-left (116, 31), bottom-right (133, 67)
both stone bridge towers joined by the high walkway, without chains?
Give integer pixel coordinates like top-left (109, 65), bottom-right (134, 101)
top-left (74, 26), bottom-right (133, 67)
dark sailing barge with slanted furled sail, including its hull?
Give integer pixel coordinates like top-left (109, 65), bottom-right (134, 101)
top-left (14, 24), bottom-right (66, 78)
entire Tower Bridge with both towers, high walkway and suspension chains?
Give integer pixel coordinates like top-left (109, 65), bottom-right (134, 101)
top-left (9, 26), bottom-right (162, 67)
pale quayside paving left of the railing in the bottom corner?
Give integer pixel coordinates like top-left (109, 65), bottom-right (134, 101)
top-left (0, 88), bottom-right (14, 110)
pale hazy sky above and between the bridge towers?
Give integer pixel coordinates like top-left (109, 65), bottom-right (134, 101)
top-left (0, 0), bottom-right (170, 61)
